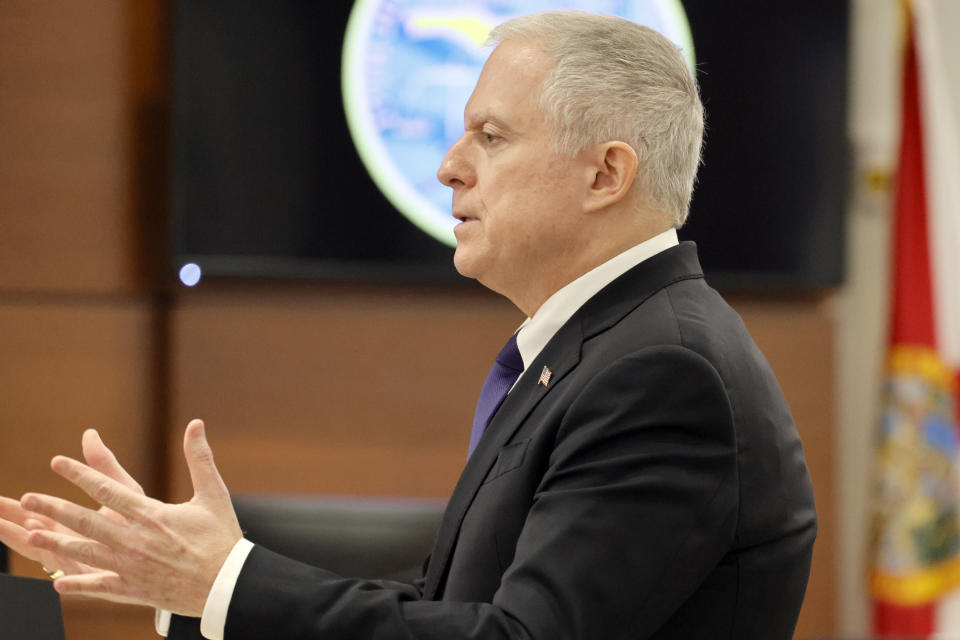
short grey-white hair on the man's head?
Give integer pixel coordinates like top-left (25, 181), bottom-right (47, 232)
top-left (487, 11), bottom-right (703, 227)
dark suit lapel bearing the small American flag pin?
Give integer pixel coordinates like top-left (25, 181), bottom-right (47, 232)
top-left (423, 242), bottom-right (703, 600)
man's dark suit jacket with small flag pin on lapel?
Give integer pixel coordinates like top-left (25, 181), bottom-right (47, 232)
top-left (172, 243), bottom-right (816, 640)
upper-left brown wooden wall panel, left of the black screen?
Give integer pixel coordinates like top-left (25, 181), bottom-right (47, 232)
top-left (0, 0), bottom-right (150, 292)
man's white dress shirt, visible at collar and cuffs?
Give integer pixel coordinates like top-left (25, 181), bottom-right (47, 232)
top-left (156, 229), bottom-right (679, 640)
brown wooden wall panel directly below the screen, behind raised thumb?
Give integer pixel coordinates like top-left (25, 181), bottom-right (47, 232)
top-left (168, 287), bottom-right (522, 499)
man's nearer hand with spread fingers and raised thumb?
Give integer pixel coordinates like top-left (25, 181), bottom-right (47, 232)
top-left (21, 420), bottom-right (242, 617)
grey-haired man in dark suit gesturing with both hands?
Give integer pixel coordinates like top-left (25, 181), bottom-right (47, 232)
top-left (0, 13), bottom-right (816, 640)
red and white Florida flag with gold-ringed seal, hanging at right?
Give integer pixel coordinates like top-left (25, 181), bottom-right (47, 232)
top-left (870, 0), bottom-right (960, 638)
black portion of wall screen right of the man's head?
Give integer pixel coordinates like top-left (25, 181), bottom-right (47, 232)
top-left (680, 0), bottom-right (848, 289)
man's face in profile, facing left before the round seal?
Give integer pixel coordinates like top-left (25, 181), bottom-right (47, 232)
top-left (437, 41), bottom-right (588, 311)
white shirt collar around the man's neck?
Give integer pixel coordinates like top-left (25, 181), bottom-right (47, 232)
top-left (517, 229), bottom-right (680, 370)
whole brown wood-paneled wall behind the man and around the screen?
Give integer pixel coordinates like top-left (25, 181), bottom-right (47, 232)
top-left (0, 0), bottom-right (836, 640)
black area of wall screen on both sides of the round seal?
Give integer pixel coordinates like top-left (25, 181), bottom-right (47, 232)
top-left (171, 0), bottom-right (848, 291)
